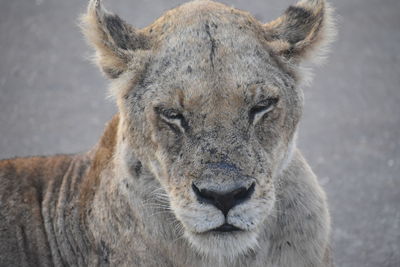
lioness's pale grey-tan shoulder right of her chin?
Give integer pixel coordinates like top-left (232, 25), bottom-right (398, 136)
top-left (266, 150), bottom-right (330, 266)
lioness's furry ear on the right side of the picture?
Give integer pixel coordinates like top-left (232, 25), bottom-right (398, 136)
top-left (264, 0), bottom-right (336, 63)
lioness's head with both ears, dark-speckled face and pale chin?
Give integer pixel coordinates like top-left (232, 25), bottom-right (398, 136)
top-left (79, 0), bottom-right (332, 257)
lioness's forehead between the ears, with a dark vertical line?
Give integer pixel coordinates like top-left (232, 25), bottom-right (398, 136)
top-left (141, 1), bottom-right (287, 107)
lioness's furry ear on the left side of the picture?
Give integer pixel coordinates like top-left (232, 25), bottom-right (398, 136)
top-left (81, 0), bottom-right (150, 79)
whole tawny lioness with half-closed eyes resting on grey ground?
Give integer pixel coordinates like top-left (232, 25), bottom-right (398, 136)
top-left (0, 0), bottom-right (332, 267)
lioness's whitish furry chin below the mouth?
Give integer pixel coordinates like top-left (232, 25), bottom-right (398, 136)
top-left (185, 230), bottom-right (258, 261)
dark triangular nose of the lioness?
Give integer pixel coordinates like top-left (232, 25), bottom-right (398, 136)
top-left (192, 183), bottom-right (255, 216)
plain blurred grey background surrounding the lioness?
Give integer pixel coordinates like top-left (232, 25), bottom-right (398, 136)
top-left (0, 0), bottom-right (400, 267)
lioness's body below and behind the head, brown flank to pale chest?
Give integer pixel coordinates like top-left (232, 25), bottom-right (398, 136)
top-left (0, 117), bottom-right (330, 267)
